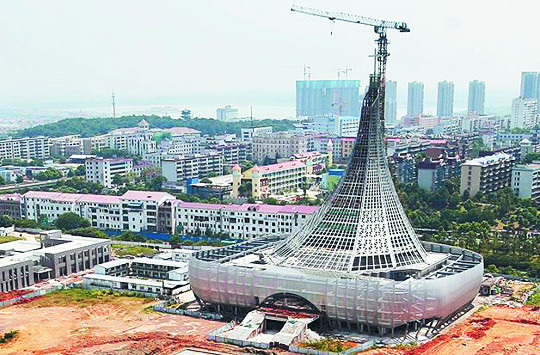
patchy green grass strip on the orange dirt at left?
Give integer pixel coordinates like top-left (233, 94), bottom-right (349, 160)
top-left (27, 287), bottom-right (150, 308)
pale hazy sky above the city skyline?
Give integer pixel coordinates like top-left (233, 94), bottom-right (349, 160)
top-left (0, 0), bottom-right (540, 119)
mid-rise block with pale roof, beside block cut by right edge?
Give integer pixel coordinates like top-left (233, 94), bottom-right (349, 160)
top-left (460, 153), bottom-right (516, 196)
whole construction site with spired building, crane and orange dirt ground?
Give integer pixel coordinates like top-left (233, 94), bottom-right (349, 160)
top-left (0, 7), bottom-right (540, 355)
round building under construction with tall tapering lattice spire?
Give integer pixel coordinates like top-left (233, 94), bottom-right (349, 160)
top-left (189, 5), bottom-right (483, 333)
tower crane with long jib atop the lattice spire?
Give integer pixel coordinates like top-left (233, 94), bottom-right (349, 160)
top-left (291, 5), bottom-right (411, 117)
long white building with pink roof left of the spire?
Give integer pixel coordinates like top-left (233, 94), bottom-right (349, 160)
top-left (20, 191), bottom-right (318, 239)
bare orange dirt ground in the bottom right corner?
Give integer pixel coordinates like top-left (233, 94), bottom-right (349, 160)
top-left (362, 306), bottom-right (540, 355)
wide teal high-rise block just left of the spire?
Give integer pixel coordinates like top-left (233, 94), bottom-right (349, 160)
top-left (296, 80), bottom-right (361, 117)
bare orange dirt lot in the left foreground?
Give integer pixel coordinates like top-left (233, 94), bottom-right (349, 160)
top-left (0, 297), bottom-right (246, 355)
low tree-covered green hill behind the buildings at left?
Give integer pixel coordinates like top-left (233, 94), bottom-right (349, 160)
top-left (14, 116), bottom-right (293, 137)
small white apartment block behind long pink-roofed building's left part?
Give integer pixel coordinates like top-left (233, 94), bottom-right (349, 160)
top-left (84, 158), bottom-right (133, 188)
